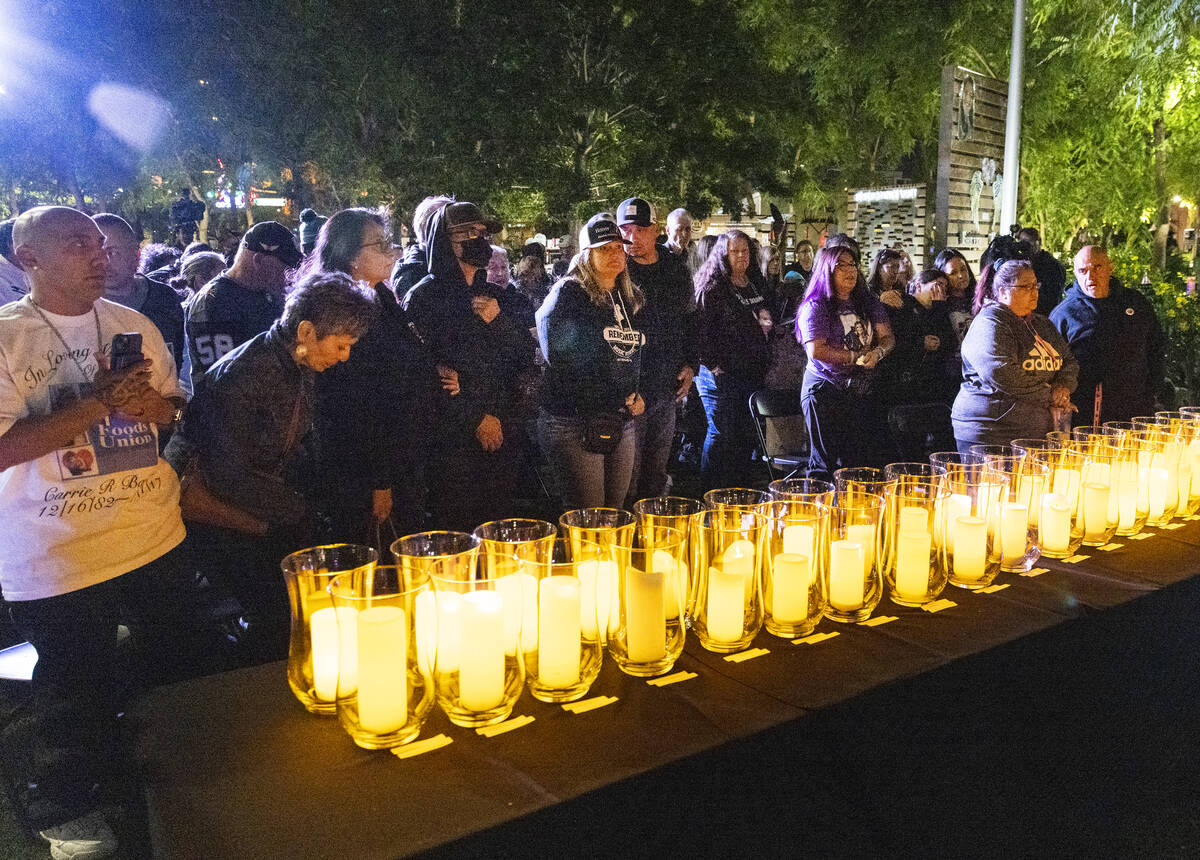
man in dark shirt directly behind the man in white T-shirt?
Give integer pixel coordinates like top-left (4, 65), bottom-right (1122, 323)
top-left (92, 212), bottom-right (184, 367)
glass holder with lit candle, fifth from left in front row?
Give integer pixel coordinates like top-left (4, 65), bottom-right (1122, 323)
top-left (692, 507), bottom-right (764, 654)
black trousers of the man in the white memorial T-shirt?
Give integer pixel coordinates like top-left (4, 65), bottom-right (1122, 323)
top-left (7, 546), bottom-right (216, 830)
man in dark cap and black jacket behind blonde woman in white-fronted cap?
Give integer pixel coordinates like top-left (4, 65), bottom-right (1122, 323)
top-left (617, 197), bottom-right (696, 503)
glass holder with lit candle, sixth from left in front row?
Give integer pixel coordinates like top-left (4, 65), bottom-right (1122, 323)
top-left (761, 499), bottom-right (829, 639)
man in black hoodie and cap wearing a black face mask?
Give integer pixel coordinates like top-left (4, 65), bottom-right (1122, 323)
top-left (403, 203), bottom-right (535, 531)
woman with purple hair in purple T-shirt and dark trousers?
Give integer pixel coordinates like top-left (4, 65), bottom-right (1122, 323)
top-left (796, 246), bottom-right (895, 481)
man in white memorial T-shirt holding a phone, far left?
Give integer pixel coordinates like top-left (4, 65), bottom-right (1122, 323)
top-left (0, 206), bottom-right (199, 856)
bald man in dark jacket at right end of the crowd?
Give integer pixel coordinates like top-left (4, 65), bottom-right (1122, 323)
top-left (1050, 245), bottom-right (1166, 425)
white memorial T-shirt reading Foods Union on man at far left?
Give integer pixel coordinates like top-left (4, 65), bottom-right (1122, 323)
top-left (0, 296), bottom-right (185, 601)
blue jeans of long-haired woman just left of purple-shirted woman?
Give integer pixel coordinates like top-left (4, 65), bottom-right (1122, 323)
top-left (696, 366), bottom-right (758, 489)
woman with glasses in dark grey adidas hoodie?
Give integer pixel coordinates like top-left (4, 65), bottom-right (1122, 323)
top-left (950, 260), bottom-right (1079, 453)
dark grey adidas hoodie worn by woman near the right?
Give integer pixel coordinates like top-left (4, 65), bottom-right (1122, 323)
top-left (950, 301), bottom-right (1079, 445)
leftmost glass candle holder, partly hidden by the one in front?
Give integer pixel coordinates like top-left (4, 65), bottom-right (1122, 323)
top-left (280, 543), bottom-right (379, 715)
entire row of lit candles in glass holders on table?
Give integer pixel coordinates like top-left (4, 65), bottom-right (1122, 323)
top-left (276, 411), bottom-right (1200, 748)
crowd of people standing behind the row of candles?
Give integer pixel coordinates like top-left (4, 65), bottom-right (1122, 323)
top-left (0, 190), bottom-right (1165, 856)
